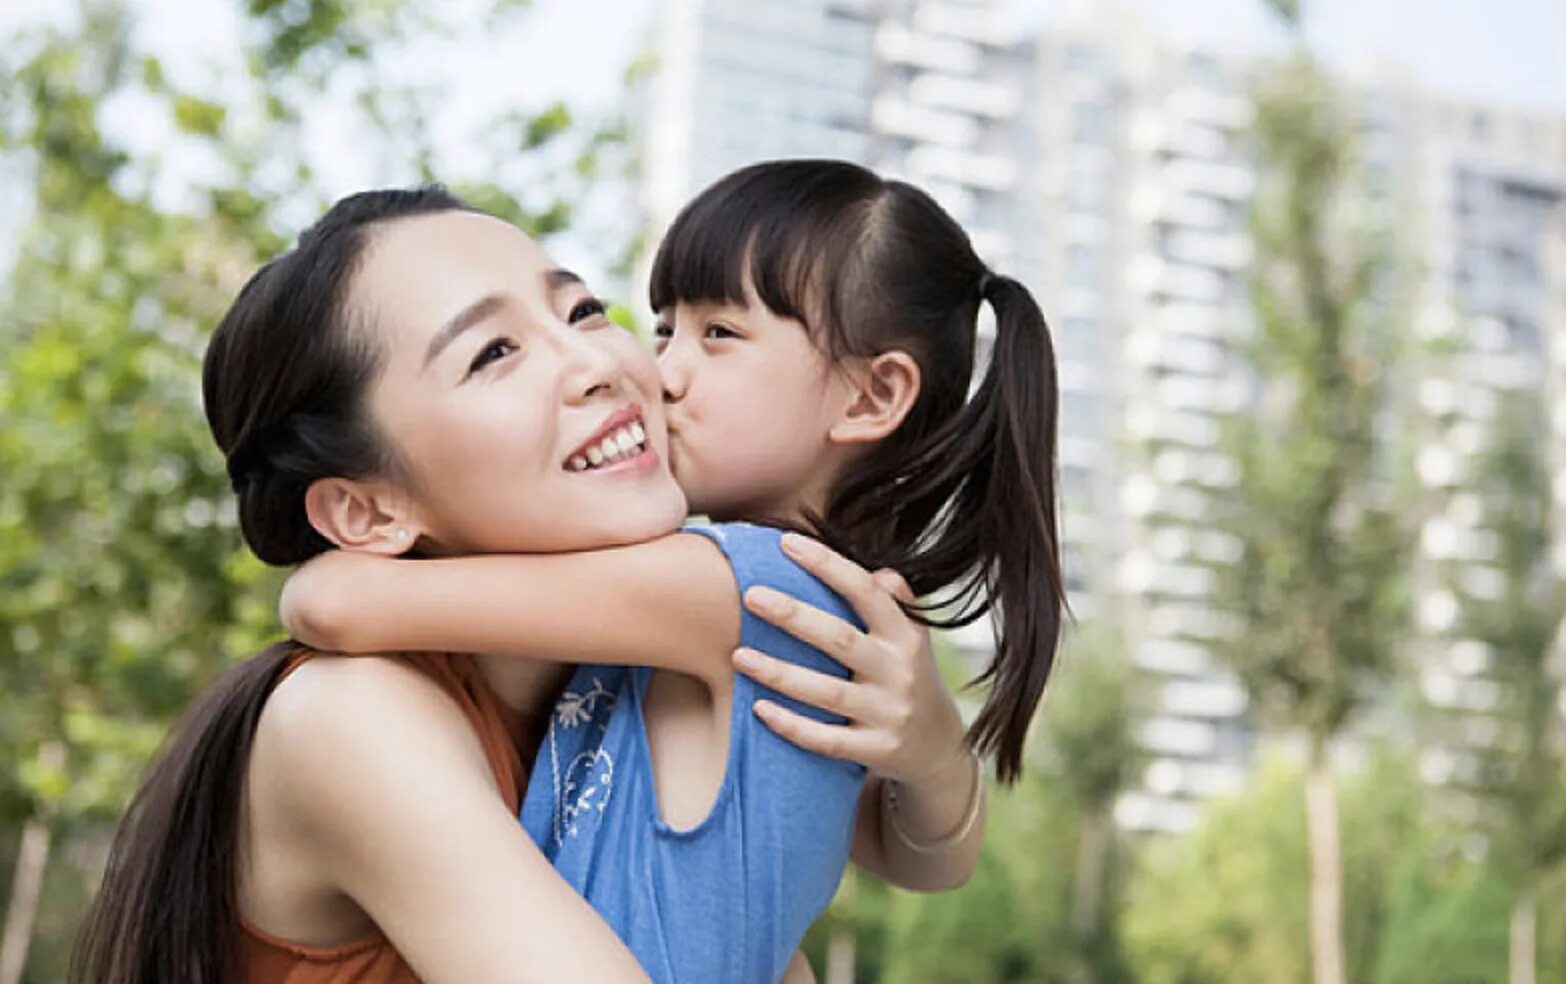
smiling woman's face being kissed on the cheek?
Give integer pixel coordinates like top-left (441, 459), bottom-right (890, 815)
top-left (360, 212), bottom-right (686, 555)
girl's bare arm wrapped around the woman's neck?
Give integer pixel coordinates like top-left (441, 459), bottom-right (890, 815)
top-left (280, 533), bottom-right (739, 683)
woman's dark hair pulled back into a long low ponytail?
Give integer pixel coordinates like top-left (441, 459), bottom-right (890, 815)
top-left (72, 186), bottom-right (467, 984)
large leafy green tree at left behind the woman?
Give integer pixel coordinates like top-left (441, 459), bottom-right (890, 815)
top-left (0, 0), bottom-right (620, 984)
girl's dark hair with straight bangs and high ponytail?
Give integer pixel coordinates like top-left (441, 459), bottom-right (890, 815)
top-left (650, 160), bottom-right (1065, 782)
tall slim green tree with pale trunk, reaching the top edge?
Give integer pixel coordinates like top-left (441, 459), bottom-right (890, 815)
top-left (1223, 0), bottom-right (1409, 984)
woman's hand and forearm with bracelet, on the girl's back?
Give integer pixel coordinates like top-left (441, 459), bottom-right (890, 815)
top-left (734, 534), bottom-right (985, 892)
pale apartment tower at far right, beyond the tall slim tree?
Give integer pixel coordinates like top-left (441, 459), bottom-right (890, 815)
top-left (1414, 100), bottom-right (1566, 807)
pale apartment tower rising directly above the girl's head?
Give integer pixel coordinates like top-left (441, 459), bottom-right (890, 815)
top-left (642, 0), bottom-right (1029, 270)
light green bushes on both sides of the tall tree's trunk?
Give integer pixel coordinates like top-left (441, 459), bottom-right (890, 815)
top-left (1124, 755), bottom-right (1510, 984)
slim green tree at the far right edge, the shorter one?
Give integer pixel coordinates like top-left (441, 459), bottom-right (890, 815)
top-left (1458, 393), bottom-right (1566, 984)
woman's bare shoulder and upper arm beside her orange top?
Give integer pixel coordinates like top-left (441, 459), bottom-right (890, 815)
top-left (249, 660), bottom-right (647, 984)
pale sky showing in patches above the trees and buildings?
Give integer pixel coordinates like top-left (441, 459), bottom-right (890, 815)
top-left (0, 0), bottom-right (1566, 285)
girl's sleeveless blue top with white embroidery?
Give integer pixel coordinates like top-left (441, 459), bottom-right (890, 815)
top-left (521, 523), bottom-right (864, 984)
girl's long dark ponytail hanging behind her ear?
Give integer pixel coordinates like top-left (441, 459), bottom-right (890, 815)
top-left (811, 273), bottom-right (1066, 782)
